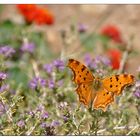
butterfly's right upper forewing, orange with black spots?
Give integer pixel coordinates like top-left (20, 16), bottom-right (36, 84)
top-left (102, 74), bottom-right (135, 95)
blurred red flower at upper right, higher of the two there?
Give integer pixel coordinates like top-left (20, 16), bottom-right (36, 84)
top-left (101, 25), bottom-right (123, 43)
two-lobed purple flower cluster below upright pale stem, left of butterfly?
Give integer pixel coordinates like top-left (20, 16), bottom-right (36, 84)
top-left (29, 77), bottom-right (46, 89)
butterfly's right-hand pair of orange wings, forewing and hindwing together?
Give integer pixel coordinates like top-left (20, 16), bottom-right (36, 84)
top-left (93, 74), bottom-right (135, 111)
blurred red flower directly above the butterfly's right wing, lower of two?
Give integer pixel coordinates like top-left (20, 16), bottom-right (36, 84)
top-left (107, 49), bottom-right (122, 69)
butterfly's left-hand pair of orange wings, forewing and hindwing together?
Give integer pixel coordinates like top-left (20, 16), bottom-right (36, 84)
top-left (68, 59), bottom-right (95, 106)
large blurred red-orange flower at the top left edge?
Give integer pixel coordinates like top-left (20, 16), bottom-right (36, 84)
top-left (17, 4), bottom-right (54, 25)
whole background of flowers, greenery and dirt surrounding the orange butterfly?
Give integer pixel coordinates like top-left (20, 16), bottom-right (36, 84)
top-left (0, 4), bottom-right (140, 135)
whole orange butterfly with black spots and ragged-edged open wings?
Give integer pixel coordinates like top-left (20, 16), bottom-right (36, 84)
top-left (67, 59), bottom-right (135, 111)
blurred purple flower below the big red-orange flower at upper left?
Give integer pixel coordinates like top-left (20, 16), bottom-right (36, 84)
top-left (21, 43), bottom-right (35, 53)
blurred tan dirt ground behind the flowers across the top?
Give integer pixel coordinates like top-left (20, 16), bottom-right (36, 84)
top-left (1, 5), bottom-right (140, 73)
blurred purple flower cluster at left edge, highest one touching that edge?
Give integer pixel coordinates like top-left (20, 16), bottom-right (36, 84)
top-left (0, 46), bottom-right (15, 57)
